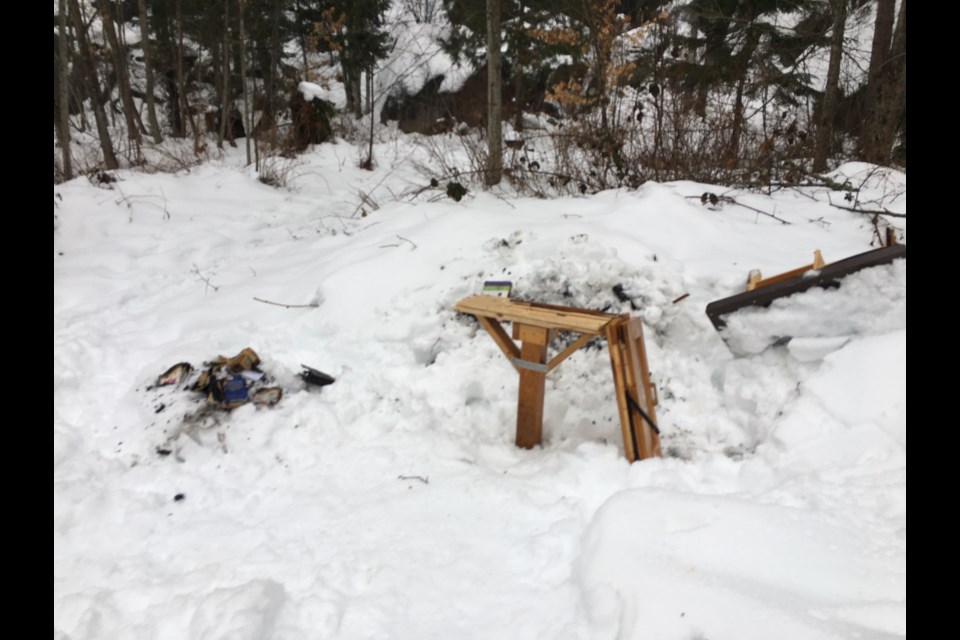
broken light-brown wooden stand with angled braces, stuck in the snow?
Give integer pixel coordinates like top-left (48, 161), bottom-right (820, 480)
top-left (454, 295), bottom-right (661, 462)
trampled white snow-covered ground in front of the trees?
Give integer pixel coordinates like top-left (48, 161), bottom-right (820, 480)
top-left (54, 138), bottom-right (906, 640)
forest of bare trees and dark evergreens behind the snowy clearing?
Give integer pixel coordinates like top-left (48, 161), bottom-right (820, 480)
top-left (54, 0), bottom-right (906, 194)
